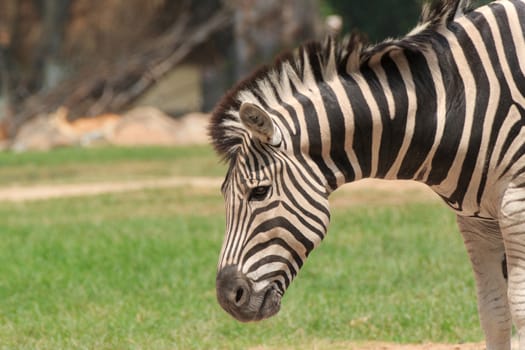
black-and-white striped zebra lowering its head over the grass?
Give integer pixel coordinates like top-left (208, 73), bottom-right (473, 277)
top-left (209, 0), bottom-right (525, 349)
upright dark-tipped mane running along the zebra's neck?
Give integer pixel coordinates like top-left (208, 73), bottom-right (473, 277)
top-left (208, 0), bottom-right (470, 161)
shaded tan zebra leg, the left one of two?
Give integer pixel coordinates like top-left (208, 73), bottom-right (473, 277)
top-left (457, 216), bottom-right (512, 350)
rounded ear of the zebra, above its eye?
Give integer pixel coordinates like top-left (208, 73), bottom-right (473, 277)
top-left (239, 102), bottom-right (282, 146)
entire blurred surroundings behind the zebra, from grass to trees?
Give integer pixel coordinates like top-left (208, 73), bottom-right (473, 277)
top-left (0, 0), bottom-right (492, 350)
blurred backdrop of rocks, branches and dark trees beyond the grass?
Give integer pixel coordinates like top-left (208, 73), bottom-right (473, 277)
top-left (0, 0), bottom-right (432, 151)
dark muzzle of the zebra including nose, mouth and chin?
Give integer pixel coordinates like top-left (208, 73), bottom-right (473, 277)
top-left (216, 266), bottom-right (281, 322)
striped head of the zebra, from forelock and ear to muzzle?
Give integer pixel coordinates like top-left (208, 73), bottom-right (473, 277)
top-left (210, 93), bottom-right (329, 322)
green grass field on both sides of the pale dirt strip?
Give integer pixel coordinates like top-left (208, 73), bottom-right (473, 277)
top-left (0, 147), bottom-right (482, 349)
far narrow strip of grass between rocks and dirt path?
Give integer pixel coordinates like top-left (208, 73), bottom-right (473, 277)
top-left (0, 146), bottom-right (225, 186)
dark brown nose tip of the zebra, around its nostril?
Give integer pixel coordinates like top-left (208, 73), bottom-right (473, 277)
top-left (216, 266), bottom-right (251, 314)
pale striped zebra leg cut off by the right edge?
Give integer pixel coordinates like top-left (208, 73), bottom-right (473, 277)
top-left (500, 180), bottom-right (525, 350)
